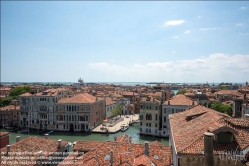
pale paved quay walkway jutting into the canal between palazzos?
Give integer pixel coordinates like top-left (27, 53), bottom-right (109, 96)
top-left (92, 114), bottom-right (139, 134)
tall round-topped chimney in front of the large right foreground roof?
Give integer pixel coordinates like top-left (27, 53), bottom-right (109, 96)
top-left (204, 132), bottom-right (214, 166)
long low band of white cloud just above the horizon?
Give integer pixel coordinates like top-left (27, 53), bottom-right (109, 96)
top-left (88, 51), bottom-right (249, 82)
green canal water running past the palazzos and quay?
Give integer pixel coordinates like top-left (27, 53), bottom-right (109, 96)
top-left (1, 123), bottom-right (169, 150)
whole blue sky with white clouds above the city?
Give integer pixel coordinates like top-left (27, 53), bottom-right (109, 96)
top-left (1, 1), bottom-right (249, 83)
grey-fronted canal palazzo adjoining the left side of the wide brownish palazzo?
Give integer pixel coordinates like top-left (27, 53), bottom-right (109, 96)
top-left (19, 88), bottom-right (70, 130)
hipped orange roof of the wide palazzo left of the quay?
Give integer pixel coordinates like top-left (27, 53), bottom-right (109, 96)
top-left (58, 93), bottom-right (102, 103)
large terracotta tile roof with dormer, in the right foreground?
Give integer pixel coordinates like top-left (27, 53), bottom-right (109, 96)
top-left (169, 105), bottom-right (249, 154)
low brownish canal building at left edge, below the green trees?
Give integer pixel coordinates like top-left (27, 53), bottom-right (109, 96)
top-left (0, 100), bottom-right (19, 127)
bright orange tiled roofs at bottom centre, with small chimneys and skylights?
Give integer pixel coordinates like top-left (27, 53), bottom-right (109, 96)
top-left (59, 136), bottom-right (172, 166)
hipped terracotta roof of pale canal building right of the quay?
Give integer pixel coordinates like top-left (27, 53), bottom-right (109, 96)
top-left (163, 94), bottom-right (198, 106)
